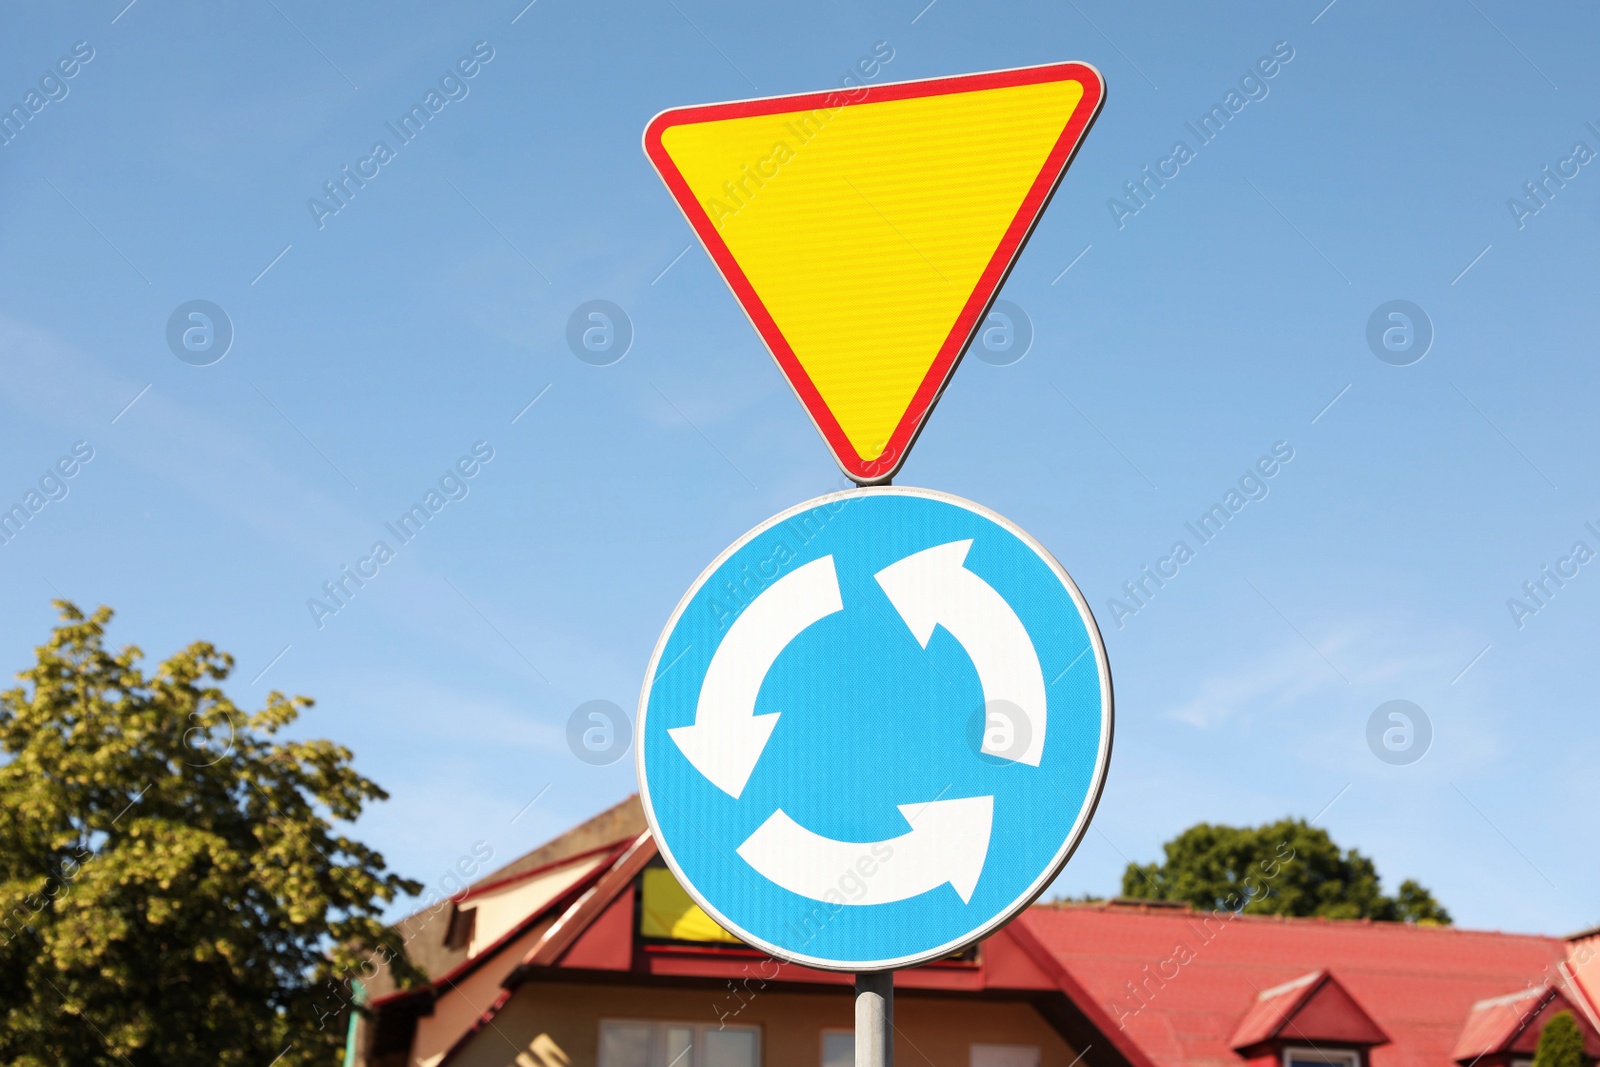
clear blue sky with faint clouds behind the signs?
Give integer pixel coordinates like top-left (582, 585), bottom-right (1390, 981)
top-left (0, 0), bottom-right (1600, 933)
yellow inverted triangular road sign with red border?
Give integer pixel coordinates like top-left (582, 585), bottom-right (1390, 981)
top-left (645, 62), bottom-right (1106, 483)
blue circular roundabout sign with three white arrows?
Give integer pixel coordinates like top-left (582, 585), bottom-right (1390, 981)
top-left (637, 486), bottom-right (1112, 971)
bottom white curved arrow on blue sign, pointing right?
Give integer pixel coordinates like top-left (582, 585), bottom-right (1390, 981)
top-left (738, 797), bottom-right (995, 905)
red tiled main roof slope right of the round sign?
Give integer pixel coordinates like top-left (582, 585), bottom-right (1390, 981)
top-left (1016, 904), bottom-right (1566, 1067)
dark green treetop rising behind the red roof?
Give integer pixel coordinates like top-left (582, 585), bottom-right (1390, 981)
top-left (1122, 819), bottom-right (1450, 925)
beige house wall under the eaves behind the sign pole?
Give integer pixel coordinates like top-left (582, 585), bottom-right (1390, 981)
top-left (451, 982), bottom-right (1078, 1067)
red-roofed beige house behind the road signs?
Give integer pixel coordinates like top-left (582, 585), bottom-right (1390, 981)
top-left (354, 798), bottom-right (1600, 1067)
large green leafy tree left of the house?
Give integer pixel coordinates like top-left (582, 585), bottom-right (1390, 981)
top-left (0, 601), bottom-right (421, 1067)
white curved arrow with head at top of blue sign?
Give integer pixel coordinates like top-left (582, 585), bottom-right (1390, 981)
top-left (874, 541), bottom-right (1046, 766)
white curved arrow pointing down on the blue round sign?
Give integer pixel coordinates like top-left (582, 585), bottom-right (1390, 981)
top-left (667, 555), bottom-right (845, 800)
